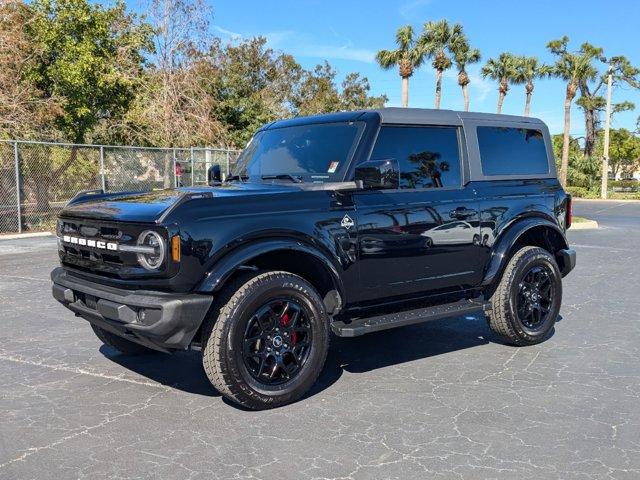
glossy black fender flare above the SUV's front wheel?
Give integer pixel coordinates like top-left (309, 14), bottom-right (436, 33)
top-left (197, 238), bottom-right (344, 298)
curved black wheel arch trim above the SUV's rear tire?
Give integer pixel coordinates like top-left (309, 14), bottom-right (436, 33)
top-left (482, 217), bottom-right (569, 286)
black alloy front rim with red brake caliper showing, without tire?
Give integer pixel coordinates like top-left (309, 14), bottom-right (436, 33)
top-left (242, 298), bottom-right (313, 386)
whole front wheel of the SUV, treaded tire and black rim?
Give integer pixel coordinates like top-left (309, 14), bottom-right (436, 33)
top-left (202, 272), bottom-right (329, 410)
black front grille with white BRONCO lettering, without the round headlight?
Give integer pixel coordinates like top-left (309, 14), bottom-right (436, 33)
top-left (57, 218), bottom-right (166, 278)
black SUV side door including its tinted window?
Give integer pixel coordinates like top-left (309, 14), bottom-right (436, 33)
top-left (354, 126), bottom-right (483, 300)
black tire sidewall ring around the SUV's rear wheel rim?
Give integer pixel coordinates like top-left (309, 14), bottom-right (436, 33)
top-left (508, 250), bottom-right (562, 343)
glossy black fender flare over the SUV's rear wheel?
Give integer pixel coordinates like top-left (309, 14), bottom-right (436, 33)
top-left (482, 217), bottom-right (569, 286)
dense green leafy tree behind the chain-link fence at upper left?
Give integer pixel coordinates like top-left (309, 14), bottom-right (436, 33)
top-left (27, 0), bottom-right (151, 143)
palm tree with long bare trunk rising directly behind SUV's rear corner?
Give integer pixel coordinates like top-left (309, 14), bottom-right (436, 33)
top-left (547, 35), bottom-right (606, 187)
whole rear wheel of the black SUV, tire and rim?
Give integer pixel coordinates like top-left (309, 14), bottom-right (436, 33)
top-left (487, 246), bottom-right (562, 345)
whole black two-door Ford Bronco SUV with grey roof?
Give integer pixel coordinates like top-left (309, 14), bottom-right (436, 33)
top-left (51, 108), bottom-right (576, 409)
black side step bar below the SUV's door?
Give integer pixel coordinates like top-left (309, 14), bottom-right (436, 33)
top-left (331, 298), bottom-right (484, 337)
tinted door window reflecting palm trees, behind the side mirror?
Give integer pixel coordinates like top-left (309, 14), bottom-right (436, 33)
top-left (371, 127), bottom-right (460, 188)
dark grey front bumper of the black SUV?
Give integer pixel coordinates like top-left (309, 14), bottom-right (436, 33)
top-left (51, 267), bottom-right (213, 352)
